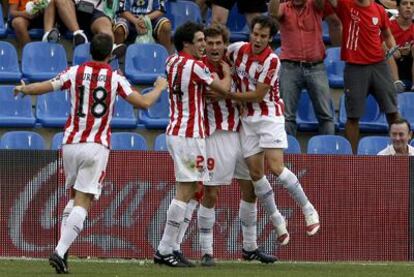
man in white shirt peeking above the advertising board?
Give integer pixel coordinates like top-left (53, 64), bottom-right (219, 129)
top-left (378, 118), bottom-right (414, 156)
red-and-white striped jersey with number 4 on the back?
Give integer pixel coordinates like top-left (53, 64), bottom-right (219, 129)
top-left (166, 52), bottom-right (213, 138)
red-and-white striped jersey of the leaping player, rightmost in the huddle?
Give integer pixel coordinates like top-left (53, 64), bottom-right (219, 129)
top-left (227, 42), bottom-right (284, 116)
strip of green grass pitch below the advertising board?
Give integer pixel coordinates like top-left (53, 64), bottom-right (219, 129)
top-left (0, 258), bottom-right (414, 277)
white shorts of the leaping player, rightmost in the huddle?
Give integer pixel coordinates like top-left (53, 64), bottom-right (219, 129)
top-left (240, 116), bottom-right (288, 158)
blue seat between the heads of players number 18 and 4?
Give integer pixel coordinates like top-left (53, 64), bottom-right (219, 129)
top-left (125, 43), bottom-right (168, 85)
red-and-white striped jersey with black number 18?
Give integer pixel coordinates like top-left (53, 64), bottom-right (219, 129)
top-left (52, 62), bottom-right (132, 147)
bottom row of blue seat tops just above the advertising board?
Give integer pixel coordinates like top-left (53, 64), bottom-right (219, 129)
top-left (0, 131), bottom-right (414, 155)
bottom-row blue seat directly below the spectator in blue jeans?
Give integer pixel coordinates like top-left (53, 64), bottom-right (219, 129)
top-left (307, 135), bottom-right (352, 155)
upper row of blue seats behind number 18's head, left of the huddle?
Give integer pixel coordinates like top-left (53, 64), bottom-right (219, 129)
top-left (0, 41), bottom-right (168, 84)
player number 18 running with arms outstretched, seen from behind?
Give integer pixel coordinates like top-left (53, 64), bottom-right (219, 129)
top-left (14, 33), bottom-right (167, 273)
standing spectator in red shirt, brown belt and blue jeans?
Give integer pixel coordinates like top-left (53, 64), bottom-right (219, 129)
top-left (269, 0), bottom-right (335, 136)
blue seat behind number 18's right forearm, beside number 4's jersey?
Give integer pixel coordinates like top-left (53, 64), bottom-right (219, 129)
top-left (138, 88), bottom-right (170, 129)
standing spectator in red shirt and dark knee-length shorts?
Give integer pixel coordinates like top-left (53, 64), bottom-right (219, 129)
top-left (329, 0), bottom-right (399, 153)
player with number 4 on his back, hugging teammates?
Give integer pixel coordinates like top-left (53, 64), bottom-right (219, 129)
top-left (154, 22), bottom-right (231, 267)
